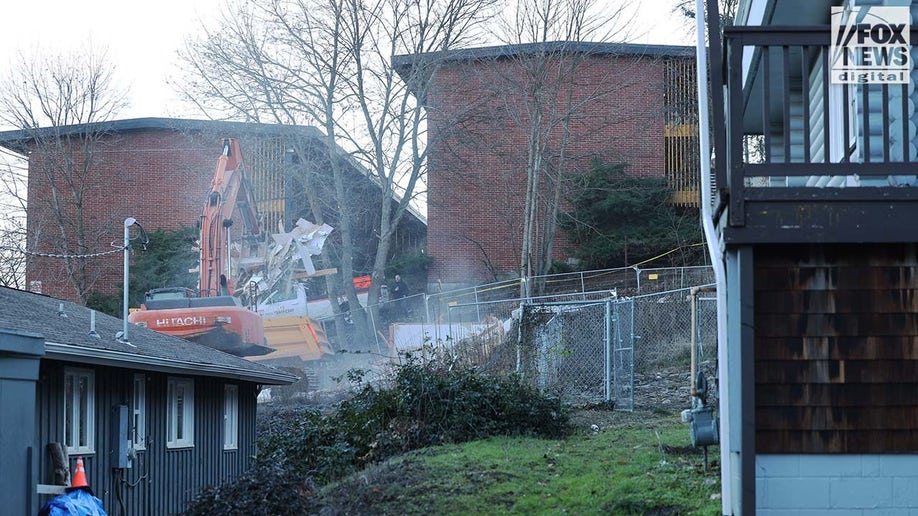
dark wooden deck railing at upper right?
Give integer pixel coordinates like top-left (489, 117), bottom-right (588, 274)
top-left (715, 26), bottom-right (918, 223)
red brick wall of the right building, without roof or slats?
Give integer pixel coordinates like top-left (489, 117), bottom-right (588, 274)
top-left (427, 52), bottom-right (676, 283)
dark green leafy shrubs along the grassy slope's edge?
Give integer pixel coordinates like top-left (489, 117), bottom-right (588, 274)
top-left (186, 357), bottom-right (570, 515)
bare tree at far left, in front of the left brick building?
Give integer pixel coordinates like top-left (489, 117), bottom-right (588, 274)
top-left (0, 49), bottom-right (126, 304)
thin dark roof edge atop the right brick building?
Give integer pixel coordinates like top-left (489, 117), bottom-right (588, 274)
top-left (392, 41), bottom-right (695, 73)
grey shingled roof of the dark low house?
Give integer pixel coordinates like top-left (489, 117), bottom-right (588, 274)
top-left (0, 287), bottom-right (296, 385)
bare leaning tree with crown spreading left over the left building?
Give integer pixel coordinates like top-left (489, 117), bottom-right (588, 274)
top-left (177, 0), bottom-right (378, 334)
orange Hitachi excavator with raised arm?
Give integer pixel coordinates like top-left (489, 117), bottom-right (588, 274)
top-left (128, 138), bottom-right (273, 356)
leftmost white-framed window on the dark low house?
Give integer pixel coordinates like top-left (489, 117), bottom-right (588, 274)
top-left (64, 369), bottom-right (96, 454)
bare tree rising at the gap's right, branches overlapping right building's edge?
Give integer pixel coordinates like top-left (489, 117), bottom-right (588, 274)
top-left (346, 0), bottom-right (495, 326)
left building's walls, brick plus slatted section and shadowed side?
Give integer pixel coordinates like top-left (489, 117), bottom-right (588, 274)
top-left (26, 127), bottom-right (425, 301)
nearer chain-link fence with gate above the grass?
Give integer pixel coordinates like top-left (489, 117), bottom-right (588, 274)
top-left (434, 287), bottom-right (717, 410)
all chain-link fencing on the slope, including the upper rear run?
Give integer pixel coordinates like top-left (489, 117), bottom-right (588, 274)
top-left (312, 267), bottom-right (717, 410)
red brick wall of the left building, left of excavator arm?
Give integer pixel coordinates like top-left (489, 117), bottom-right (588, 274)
top-left (26, 130), bottom-right (255, 300)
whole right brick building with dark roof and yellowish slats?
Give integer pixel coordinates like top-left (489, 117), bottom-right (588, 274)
top-left (393, 42), bottom-right (698, 289)
